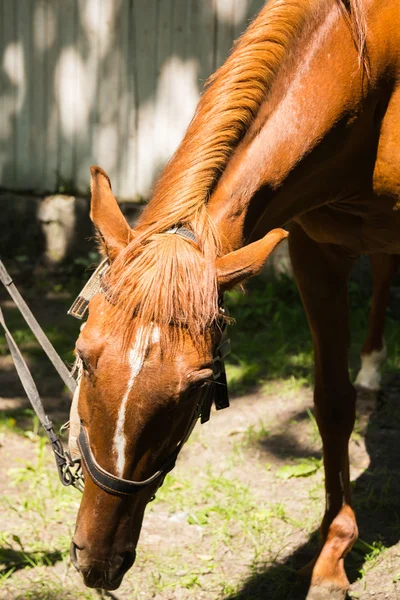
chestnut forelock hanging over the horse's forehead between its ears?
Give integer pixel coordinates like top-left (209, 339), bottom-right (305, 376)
top-left (107, 216), bottom-right (218, 352)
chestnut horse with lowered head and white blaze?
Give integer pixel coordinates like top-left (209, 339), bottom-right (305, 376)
top-left (71, 0), bottom-right (400, 599)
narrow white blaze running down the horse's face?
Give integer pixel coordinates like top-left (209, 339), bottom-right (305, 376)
top-left (114, 327), bottom-right (160, 477)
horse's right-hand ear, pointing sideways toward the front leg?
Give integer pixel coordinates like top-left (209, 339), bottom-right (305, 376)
top-left (217, 229), bottom-right (289, 291)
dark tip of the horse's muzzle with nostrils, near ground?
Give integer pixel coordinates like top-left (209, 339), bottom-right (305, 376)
top-left (70, 541), bottom-right (136, 590)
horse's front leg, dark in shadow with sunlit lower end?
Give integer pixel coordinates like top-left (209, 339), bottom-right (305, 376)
top-left (289, 224), bottom-right (358, 600)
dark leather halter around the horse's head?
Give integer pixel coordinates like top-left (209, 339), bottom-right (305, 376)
top-left (70, 226), bottom-right (230, 498)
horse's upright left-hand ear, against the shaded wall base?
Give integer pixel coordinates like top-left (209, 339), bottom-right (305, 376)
top-left (90, 167), bottom-right (132, 260)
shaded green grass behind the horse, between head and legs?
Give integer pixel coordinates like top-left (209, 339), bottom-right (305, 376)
top-left (226, 276), bottom-right (400, 394)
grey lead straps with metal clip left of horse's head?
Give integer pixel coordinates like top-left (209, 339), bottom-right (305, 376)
top-left (0, 261), bottom-right (83, 492)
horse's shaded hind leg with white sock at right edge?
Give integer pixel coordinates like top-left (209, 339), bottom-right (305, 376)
top-left (355, 254), bottom-right (400, 391)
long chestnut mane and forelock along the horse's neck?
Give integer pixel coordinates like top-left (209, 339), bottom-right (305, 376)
top-left (104, 0), bottom-right (365, 352)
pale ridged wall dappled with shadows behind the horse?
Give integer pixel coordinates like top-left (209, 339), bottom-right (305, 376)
top-left (0, 0), bottom-right (265, 198)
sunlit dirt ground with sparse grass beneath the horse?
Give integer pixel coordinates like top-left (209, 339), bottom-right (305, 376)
top-left (0, 282), bottom-right (400, 600)
